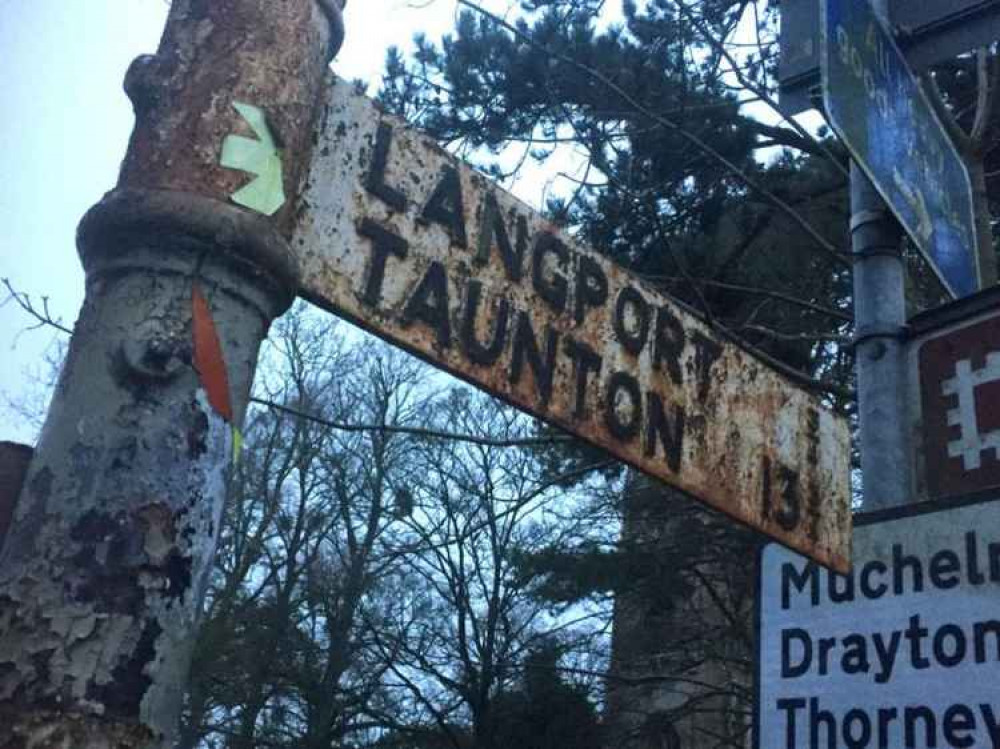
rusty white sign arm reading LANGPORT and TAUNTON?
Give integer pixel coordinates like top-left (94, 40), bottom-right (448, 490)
top-left (293, 74), bottom-right (850, 568)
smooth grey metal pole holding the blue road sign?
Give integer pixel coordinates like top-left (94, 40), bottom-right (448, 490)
top-left (851, 0), bottom-right (913, 511)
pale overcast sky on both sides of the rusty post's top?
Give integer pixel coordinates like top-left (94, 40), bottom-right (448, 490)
top-left (0, 0), bottom-right (508, 440)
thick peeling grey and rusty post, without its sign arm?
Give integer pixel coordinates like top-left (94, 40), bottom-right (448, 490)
top-left (0, 0), bottom-right (342, 749)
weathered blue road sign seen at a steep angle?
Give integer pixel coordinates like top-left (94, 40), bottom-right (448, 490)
top-left (820, 0), bottom-right (979, 297)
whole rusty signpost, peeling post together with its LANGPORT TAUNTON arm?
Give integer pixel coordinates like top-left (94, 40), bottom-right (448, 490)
top-left (0, 0), bottom-right (851, 749)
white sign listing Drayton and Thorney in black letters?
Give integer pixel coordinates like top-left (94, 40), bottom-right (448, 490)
top-left (756, 501), bottom-right (1000, 749)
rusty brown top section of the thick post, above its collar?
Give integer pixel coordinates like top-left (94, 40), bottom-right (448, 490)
top-left (119, 0), bottom-right (342, 237)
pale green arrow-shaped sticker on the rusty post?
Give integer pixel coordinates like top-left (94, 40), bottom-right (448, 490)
top-left (219, 101), bottom-right (285, 216)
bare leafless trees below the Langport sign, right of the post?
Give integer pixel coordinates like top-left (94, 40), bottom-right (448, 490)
top-left (171, 311), bottom-right (607, 749)
